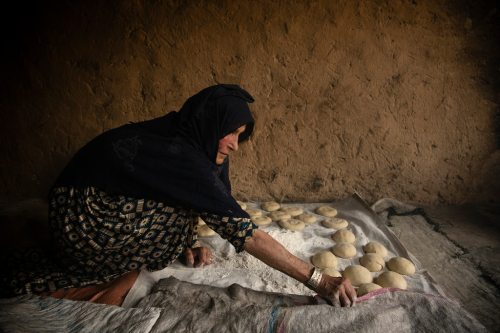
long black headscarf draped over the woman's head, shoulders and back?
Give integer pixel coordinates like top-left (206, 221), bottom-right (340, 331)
top-left (54, 85), bottom-right (254, 217)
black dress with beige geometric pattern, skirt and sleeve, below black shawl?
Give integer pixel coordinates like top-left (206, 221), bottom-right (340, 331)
top-left (2, 187), bottom-right (257, 296)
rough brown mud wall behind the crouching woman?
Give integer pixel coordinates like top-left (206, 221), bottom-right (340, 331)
top-left (0, 0), bottom-right (500, 204)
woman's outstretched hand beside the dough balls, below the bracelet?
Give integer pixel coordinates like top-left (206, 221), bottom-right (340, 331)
top-left (316, 274), bottom-right (356, 306)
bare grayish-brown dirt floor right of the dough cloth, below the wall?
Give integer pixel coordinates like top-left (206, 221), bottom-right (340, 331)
top-left (388, 202), bottom-right (500, 332)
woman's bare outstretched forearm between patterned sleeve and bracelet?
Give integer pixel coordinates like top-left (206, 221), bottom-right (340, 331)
top-left (245, 230), bottom-right (313, 283)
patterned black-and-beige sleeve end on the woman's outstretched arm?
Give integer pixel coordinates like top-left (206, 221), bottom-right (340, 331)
top-left (200, 213), bottom-right (258, 252)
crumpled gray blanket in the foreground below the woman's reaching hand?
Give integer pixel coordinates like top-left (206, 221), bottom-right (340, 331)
top-left (134, 278), bottom-right (486, 333)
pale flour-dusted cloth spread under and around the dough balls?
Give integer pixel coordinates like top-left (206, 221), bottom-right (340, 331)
top-left (123, 195), bottom-right (441, 306)
